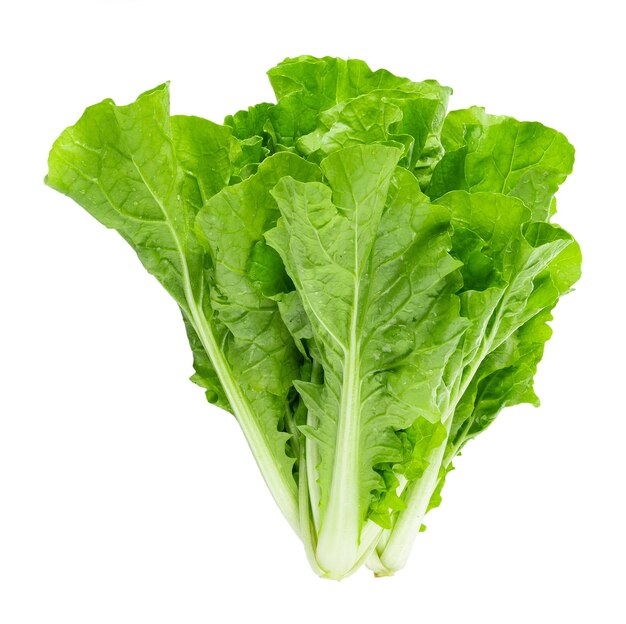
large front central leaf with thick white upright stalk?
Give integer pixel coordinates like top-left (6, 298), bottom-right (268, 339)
top-left (266, 145), bottom-right (463, 574)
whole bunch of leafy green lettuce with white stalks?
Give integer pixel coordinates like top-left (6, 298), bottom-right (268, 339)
top-left (46, 57), bottom-right (581, 579)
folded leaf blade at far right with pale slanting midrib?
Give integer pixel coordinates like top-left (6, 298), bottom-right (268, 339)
top-left (428, 192), bottom-right (580, 454)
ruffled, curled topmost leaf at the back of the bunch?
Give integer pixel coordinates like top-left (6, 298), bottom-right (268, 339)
top-left (268, 56), bottom-right (451, 181)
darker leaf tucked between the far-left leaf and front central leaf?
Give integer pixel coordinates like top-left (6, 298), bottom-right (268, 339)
top-left (196, 153), bottom-right (321, 398)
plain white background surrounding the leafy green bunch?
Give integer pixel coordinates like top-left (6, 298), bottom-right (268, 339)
top-left (0, 0), bottom-right (626, 624)
